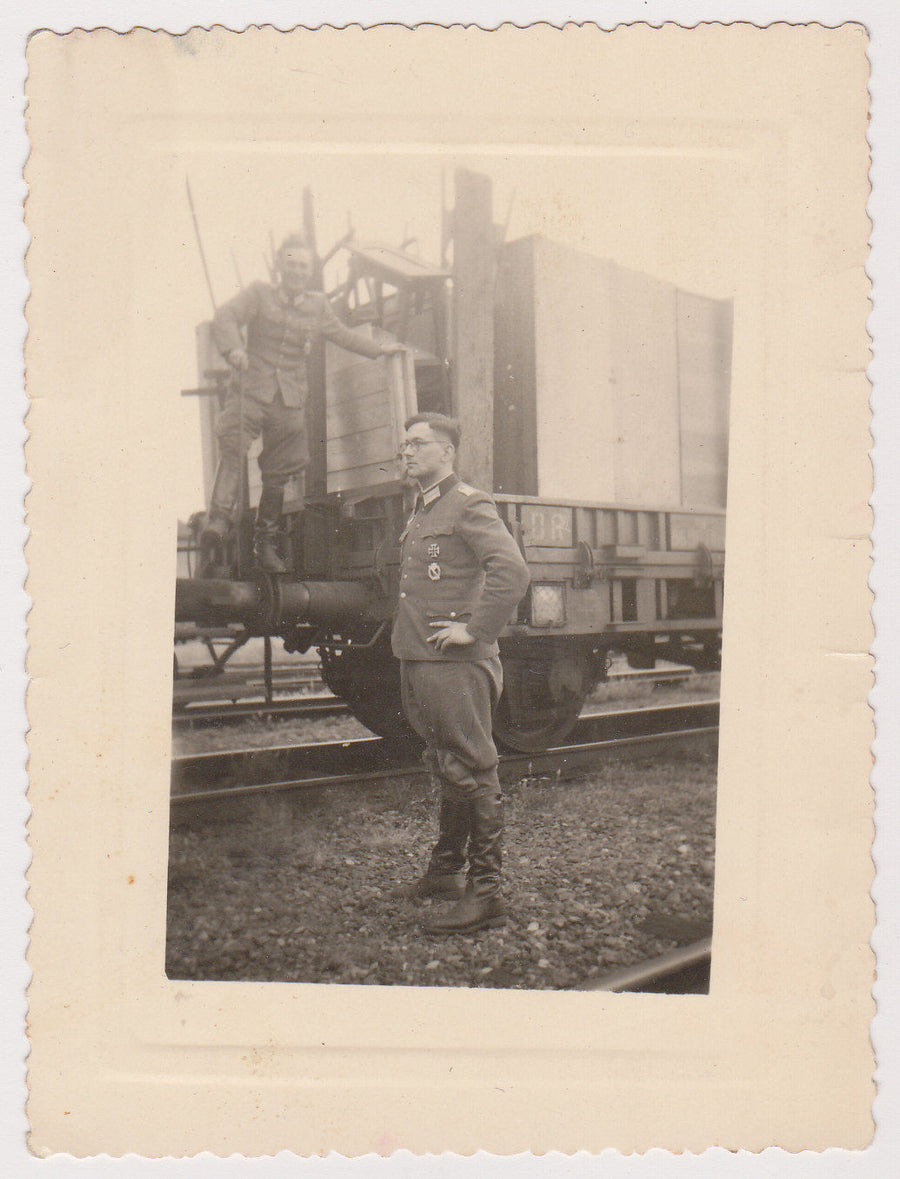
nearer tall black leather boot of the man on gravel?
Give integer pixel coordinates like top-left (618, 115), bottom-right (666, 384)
top-left (425, 772), bottom-right (506, 934)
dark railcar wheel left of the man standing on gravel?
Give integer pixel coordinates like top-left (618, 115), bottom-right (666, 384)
top-left (320, 641), bottom-right (418, 740)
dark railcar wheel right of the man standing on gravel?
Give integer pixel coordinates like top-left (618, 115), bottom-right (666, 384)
top-left (494, 645), bottom-right (602, 753)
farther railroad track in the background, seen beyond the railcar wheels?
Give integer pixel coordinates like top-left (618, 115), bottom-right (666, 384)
top-left (172, 664), bottom-right (696, 730)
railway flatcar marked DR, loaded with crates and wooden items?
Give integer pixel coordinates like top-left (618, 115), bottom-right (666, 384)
top-left (176, 171), bottom-right (731, 752)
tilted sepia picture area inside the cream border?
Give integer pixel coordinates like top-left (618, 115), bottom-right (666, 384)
top-left (166, 152), bottom-right (737, 994)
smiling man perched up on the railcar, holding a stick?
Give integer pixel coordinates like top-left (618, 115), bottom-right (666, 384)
top-left (202, 237), bottom-right (402, 573)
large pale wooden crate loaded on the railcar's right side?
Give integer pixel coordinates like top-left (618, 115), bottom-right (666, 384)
top-left (494, 237), bottom-right (731, 507)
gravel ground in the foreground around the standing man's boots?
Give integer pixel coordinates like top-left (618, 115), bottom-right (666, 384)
top-left (166, 738), bottom-right (716, 989)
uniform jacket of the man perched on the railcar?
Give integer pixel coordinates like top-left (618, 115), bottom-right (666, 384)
top-left (212, 283), bottom-right (381, 409)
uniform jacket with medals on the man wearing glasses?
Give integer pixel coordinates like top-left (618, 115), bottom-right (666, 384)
top-left (392, 475), bottom-right (530, 660)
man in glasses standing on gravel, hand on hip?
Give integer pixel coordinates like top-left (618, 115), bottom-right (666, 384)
top-left (392, 414), bottom-right (528, 934)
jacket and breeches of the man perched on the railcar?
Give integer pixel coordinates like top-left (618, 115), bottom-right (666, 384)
top-left (212, 283), bottom-right (381, 487)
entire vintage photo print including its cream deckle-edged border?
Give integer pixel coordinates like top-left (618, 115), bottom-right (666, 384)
top-left (25, 24), bottom-right (874, 1158)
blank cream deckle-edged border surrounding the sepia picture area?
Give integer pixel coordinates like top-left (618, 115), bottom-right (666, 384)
top-left (26, 25), bottom-right (874, 1157)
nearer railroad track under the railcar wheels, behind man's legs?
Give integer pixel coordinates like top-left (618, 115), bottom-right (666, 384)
top-left (171, 702), bottom-right (718, 812)
